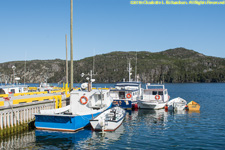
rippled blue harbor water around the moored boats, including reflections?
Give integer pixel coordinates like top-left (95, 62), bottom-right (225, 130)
top-left (0, 83), bottom-right (225, 150)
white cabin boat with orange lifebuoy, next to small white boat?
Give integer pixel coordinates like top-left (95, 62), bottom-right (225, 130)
top-left (138, 83), bottom-right (170, 109)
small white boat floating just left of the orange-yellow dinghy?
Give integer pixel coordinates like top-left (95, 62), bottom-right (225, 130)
top-left (167, 97), bottom-right (187, 111)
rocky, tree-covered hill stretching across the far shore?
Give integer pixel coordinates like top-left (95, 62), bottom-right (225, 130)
top-left (0, 48), bottom-right (225, 83)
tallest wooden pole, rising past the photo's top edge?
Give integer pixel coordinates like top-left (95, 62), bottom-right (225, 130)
top-left (70, 0), bottom-right (73, 90)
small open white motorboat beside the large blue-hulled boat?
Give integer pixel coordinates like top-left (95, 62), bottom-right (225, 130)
top-left (90, 107), bottom-right (126, 131)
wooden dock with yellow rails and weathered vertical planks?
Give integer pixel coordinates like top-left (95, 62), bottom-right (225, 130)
top-left (0, 91), bottom-right (69, 138)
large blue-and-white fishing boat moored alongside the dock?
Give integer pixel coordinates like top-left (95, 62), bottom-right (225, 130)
top-left (35, 84), bottom-right (112, 132)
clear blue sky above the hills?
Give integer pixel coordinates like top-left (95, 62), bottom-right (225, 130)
top-left (0, 0), bottom-right (225, 63)
